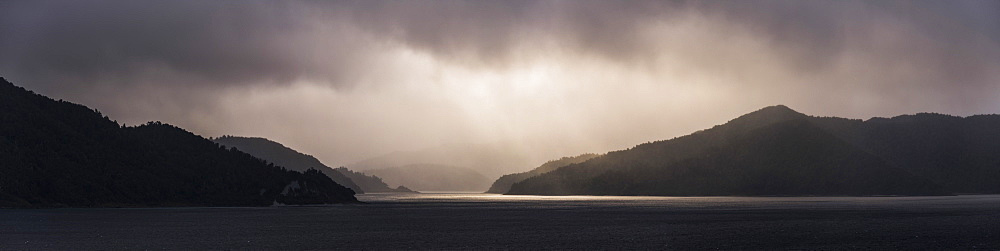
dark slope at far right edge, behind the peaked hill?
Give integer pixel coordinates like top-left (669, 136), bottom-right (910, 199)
top-left (812, 113), bottom-right (1000, 193)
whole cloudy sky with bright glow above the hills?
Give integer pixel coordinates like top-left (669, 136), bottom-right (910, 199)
top-left (0, 0), bottom-right (1000, 168)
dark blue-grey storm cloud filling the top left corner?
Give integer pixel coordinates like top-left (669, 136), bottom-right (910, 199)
top-left (0, 1), bottom-right (372, 90)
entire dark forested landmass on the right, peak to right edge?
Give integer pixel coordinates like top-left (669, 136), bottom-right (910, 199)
top-left (508, 106), bottom-right (1000, 196)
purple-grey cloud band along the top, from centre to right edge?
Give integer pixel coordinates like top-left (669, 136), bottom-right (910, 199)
top-left (341, 0), bottom-right (1000, 76)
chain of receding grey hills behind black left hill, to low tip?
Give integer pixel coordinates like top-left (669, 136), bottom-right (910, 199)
top-left (213, 135), bottom-right (414, 194)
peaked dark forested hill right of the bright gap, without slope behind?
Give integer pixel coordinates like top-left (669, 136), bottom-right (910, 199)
top-left (508, 106), bottom-right (952, 196)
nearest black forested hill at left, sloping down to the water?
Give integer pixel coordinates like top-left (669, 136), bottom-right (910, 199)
top-left (0, 78), bottom-right (357, 207)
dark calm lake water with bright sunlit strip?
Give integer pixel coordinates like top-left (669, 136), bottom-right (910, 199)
top-left (0, 193), bottom-right (1000, 250)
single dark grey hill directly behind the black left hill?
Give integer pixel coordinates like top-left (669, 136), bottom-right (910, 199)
top-left (213, 136), bottom-right (364, 193)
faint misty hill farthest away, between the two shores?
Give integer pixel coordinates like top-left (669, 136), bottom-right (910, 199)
top-left (365, 164), bottom-right (489, 191)
